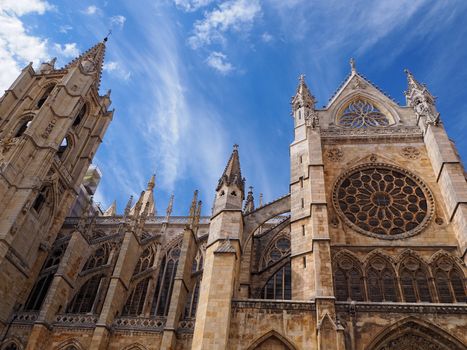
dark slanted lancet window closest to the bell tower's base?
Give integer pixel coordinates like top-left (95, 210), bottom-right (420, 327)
top-left (25, 243), bottom-right (67, 311)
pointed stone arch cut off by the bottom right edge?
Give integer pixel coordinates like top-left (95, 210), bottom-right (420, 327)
top-left (365, 317), bottom-right (465, 350)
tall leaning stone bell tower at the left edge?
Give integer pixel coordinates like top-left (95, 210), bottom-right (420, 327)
top-left (0, 38), bottom-right (113, 329)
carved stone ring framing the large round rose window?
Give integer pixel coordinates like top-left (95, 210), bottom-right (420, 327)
top-left (332, 163), bottom-right (435, 240)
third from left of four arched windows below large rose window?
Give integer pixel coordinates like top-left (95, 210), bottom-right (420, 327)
top-left (400, 257), bottom-right (432, 303)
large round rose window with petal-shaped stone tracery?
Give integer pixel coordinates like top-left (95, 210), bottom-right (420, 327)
top-left (333, 164), bottom-right (433, 239)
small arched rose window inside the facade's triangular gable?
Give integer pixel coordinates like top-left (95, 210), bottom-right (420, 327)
top-left (338, 100), bottom-right (390, 128)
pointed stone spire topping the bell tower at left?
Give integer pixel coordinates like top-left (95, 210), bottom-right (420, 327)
top-left (64, 37), bottom-right (107, 90)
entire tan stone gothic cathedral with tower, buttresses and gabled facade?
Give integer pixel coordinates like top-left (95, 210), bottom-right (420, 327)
top-left (0, 40), bottom-right (467, 350)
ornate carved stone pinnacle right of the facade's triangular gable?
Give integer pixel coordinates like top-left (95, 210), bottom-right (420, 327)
top-left (404, 69), bottom-right (440, 125)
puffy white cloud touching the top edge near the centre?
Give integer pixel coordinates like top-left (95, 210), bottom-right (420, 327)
top-left (188, 0), bottom-right (261, 48)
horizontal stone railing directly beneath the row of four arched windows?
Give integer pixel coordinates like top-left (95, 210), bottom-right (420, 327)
top-left (336, 301), bottom-right (467, 314)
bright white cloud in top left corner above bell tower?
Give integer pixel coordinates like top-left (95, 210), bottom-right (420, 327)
top-left (0, 0), bottom-right (53, 90)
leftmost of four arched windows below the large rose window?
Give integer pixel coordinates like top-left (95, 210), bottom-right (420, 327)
top-left (334, 255), bottom-right (364, 301)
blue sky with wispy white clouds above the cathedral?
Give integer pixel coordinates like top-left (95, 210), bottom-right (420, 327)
top-left (0, 0), bottom-right (467, 215)
